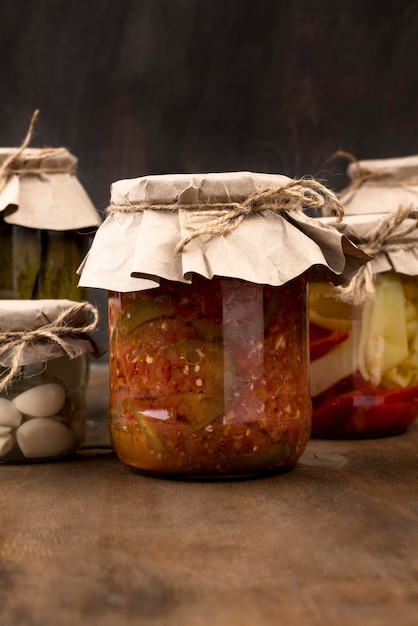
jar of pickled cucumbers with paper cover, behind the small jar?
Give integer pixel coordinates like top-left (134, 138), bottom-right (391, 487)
top-left (0, 110), bottom-right (101, 300)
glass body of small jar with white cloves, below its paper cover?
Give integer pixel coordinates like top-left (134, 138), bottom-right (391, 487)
top-left (0, 354), bottom-right (88, 463)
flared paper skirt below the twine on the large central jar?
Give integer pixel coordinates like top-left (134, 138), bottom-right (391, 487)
top-left (77, 212), bottom-right (370, 292)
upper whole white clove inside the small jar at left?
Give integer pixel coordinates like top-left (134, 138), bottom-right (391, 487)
top-left (13, 383), bottom-right (65, 417)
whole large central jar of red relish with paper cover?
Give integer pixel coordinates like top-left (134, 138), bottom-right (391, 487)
top-left (80, 172), bottom-right (365, 479)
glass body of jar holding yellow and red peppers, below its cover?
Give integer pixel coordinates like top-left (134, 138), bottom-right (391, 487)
top-left (309, 270), bottom-right (418, 439)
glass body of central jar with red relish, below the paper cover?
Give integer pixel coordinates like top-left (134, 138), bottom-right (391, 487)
top-left (109, 274), bottom-right (311, 478)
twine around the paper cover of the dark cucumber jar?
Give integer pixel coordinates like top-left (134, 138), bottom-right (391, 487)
top-left (0, 109), bottom-right (76, 193)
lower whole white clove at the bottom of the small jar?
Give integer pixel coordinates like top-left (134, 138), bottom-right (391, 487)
top-left (16, 417), bottom-right (75, 459)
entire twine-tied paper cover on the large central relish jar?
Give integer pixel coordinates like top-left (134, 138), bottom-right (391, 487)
top-left (79, 172), bottom-right (369, 292)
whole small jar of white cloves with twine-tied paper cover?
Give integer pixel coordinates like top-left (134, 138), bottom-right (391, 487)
top-left (0, 300), bottom-right (103, 463)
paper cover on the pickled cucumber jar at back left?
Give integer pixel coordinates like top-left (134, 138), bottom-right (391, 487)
top-left (0, 148), bottom-right (101, 231)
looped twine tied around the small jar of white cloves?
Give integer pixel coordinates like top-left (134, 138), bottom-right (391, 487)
top-left (0, 302), bottom-right (99, 392)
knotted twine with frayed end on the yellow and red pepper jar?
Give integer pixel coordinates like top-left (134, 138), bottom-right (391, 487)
top-left (336, 205), bottom-right (418, 305)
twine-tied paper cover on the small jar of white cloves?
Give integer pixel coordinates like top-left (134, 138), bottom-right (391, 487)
top-left (0, 300), bottom-right (104, 386)
